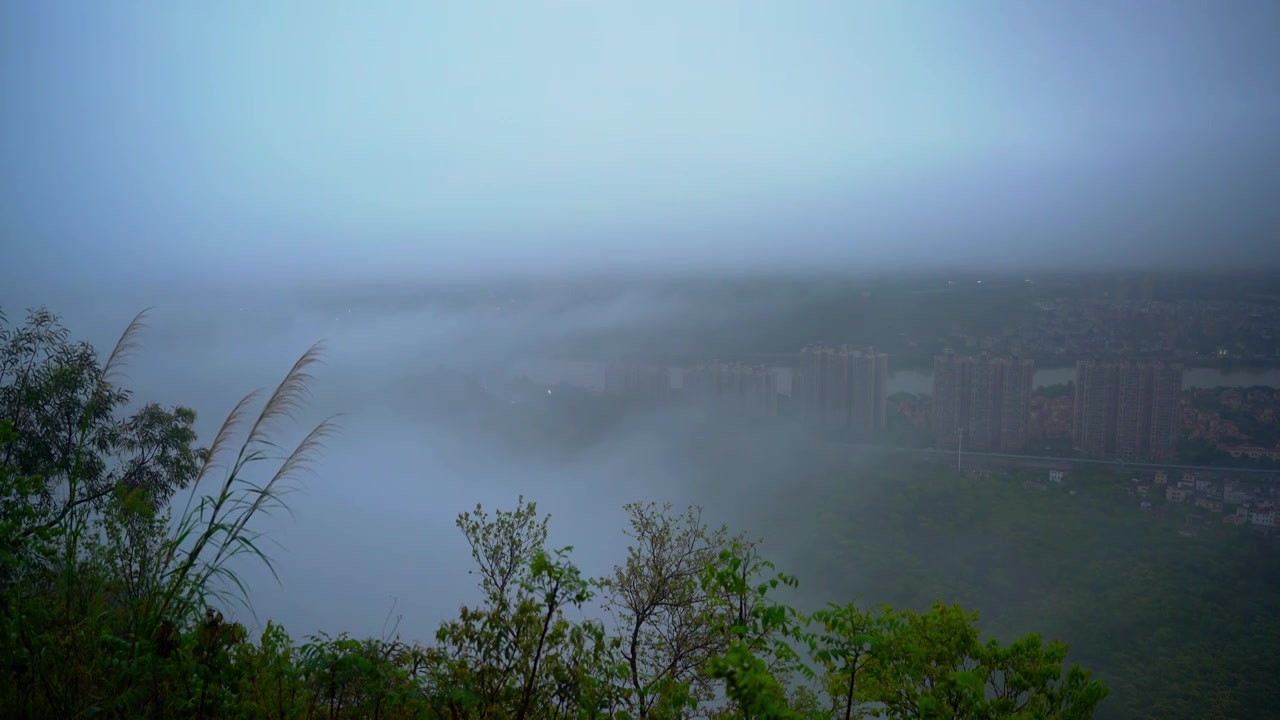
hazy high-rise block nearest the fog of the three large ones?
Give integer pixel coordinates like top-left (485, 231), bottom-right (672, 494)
top-left (792, 345), bottom-right (888, 439)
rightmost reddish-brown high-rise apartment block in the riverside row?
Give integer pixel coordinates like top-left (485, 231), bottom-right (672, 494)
top-left (1071, 360), bottom-right (1183, 460)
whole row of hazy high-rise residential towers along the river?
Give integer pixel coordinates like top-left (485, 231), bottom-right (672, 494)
top-left (605, 345), bottom-right (1183, 460)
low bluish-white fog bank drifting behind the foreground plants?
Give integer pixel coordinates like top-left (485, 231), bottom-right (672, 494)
top-left (6, 283), bottom-right (839, 641)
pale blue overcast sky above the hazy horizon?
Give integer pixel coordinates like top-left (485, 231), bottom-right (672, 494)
top-left (0, 0), bottom-right (1280, 287)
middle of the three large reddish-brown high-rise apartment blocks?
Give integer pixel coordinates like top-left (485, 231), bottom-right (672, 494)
top-left (933, 355), bottom-right (1036, 450)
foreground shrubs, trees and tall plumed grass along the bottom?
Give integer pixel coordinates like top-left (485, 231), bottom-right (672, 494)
top-left (0, 304), bottom-right (1106, 719)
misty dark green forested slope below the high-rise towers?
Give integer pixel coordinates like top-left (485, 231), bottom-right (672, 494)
top-left (768, 457), bottom-right (1280, 720)
